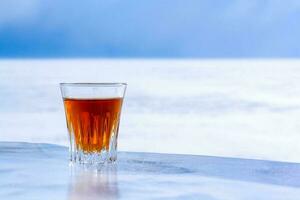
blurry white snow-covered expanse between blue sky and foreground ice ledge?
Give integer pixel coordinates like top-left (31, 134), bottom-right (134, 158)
top-left (0, 59), bottom-right (300, 162)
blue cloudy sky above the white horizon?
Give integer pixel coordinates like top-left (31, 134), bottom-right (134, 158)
top-left (0, 0), bottom-right (300, 58)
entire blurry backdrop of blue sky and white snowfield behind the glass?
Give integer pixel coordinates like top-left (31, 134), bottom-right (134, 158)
top-left (0, 0), bottom-right (300, 162)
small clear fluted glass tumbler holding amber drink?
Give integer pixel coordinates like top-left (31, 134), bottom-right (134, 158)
top-left (60, 83), bottom-right (126, 164)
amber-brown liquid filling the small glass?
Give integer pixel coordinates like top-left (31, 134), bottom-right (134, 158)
top-left (64, 98), bottom-right (123, 153)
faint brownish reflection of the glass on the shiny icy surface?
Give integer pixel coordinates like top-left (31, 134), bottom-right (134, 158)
top-left (68, 165), bottom-right (119, 200)
